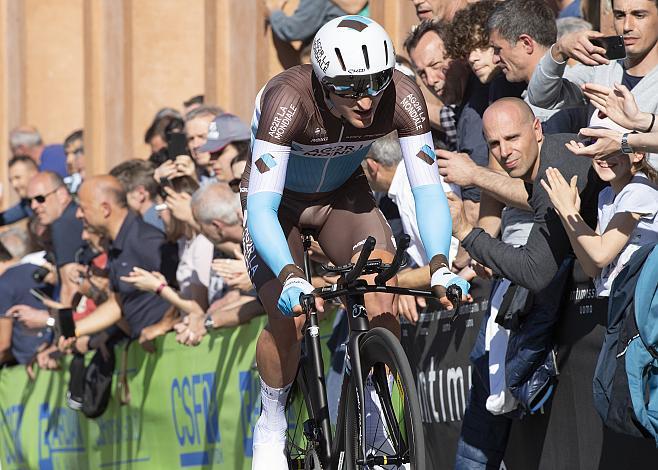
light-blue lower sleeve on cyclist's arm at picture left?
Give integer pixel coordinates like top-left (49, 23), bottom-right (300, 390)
top-left (247, 191), bottom-right (295, 276)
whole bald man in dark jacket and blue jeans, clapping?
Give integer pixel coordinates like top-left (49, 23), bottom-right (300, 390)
top-left (450, 98), bottom-right (604, 470)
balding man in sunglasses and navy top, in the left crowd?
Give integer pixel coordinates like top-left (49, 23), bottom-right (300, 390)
top-left (26, 171), bottom-right (84, 305)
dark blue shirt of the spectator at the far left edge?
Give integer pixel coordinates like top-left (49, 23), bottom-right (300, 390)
top-left (0, 264), bottom-right (52, 364)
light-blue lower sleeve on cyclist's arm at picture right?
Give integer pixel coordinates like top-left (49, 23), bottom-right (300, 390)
top-left (411, 184), bottom-right (452, 259)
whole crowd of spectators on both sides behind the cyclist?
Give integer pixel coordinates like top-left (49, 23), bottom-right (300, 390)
top-left (0, 0), bottom-right (658, 468)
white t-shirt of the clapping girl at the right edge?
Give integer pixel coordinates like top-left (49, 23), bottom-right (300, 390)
top-left (594, 173), bottom-right (658, 297)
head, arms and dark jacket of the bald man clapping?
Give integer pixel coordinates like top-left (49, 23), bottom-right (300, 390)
top-left (452, 98), bottom-right (604, 292)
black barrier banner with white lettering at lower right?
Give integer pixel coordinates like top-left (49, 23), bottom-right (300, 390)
top-left (402, 283), bottom-right (658, 470)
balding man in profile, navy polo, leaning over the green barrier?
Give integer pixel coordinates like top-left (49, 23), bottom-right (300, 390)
top-left (76, 175), bottom-right (177, 338)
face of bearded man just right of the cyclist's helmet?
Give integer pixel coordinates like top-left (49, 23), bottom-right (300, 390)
top-left (411, 32), bottom-right (469, 104)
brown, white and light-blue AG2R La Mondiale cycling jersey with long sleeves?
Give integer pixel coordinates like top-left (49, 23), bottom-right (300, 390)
top-left (243, 65), bottom-right (452, 275)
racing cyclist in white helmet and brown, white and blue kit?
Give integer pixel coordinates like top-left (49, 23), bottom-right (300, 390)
top-left (241, 16), bottom-right (469, 470)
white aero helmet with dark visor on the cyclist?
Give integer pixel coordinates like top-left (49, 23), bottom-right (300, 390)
top-left (311, 15), bottom-right (395, 98)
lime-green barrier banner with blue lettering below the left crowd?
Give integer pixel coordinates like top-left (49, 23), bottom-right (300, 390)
top-left (0, 308), bottom-right (333, 470)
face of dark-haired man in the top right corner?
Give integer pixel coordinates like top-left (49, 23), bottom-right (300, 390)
top-left (612, 0), bottom-right (658, 58)
